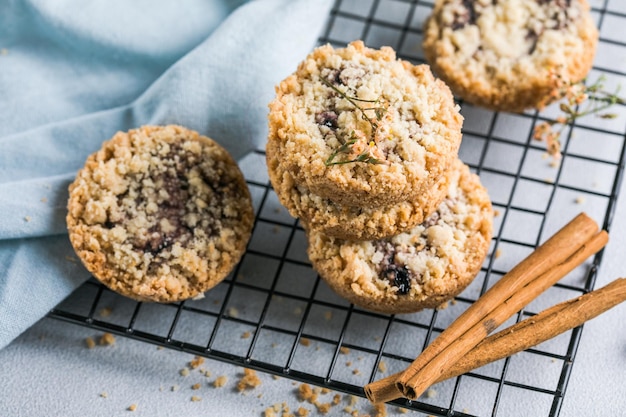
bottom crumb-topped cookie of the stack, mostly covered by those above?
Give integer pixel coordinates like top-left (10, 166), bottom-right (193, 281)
top-left (308, 161), bottom-right (493, 314)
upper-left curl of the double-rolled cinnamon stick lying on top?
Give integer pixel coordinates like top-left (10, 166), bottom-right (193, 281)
top-left (390, 213), bottom-right (598, 398)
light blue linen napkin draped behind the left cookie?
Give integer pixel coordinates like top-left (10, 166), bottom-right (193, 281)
top-left (0, 0), bottom-right (331, 348)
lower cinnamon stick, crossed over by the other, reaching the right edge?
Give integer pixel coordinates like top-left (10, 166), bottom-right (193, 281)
top-left (365, 278), bottom-right (626, 403)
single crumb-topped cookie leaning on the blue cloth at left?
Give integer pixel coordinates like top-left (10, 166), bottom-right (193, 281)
top-left (67, 126), bottom-right (254, 302)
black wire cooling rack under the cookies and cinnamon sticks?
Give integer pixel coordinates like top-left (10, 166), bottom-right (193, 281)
top-left (49, 0), bottom-right (626, 416)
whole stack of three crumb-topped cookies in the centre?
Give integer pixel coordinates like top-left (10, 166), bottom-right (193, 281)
top-left (266, 41), bottom-right (492, 313)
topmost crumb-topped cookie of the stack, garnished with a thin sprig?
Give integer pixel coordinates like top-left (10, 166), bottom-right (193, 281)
top-left (268, 41), bottom-right (463, 207)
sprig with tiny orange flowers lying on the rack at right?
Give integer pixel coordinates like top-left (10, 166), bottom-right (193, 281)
top-left (533, 73), bottom-right (626, 159)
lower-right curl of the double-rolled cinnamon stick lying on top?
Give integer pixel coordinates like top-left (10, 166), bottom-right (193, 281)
top-left (396, 231), bottom-right (608, 400)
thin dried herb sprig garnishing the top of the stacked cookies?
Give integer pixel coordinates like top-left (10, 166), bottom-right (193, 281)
top-left (320, 77), bottom-right (387, 166)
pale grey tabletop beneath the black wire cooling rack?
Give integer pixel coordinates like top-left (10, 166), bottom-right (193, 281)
top-left (0, 0), bottom-right (626, 417)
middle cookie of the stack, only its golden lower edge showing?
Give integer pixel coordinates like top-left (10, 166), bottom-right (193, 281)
top-left (268, 138), bottom-right (455, 240)
